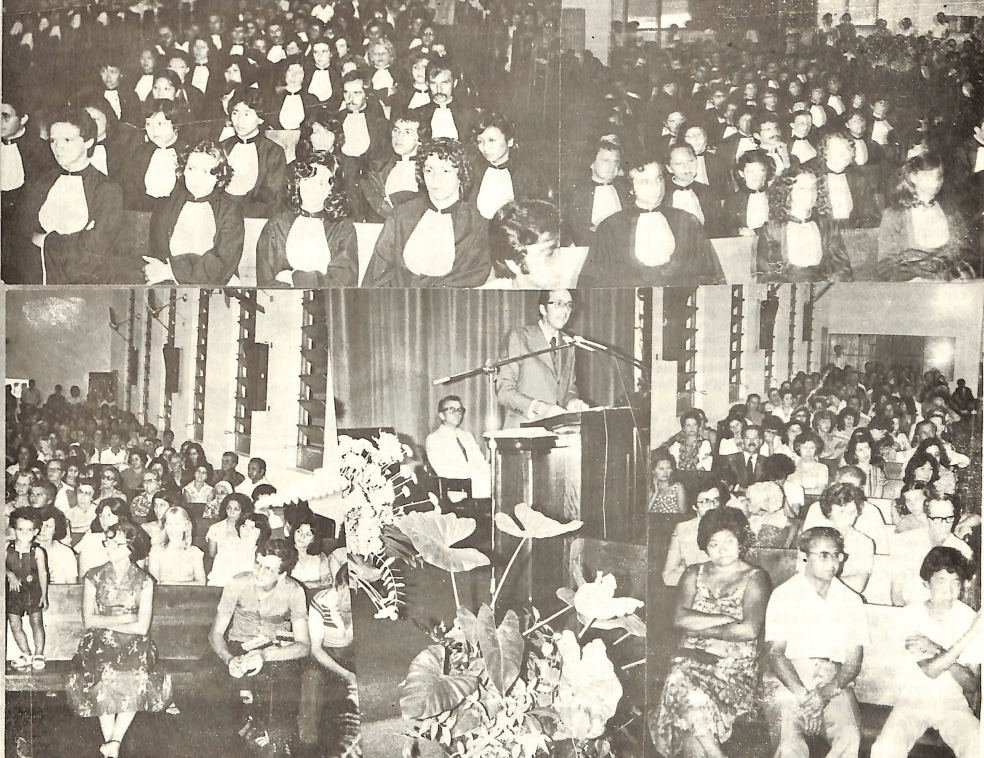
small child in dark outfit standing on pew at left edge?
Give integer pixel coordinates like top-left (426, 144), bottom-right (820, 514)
top-left (7, 508), bottom-right (48, 671)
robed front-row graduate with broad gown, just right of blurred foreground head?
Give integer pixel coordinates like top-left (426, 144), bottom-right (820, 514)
top-left (582, 148), bottom-right (724, 287)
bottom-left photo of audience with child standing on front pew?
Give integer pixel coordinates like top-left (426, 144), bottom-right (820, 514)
top-left (5, 289), bottom-right (359, 756)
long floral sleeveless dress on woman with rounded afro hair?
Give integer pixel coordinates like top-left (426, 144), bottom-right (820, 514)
top-left (650, 564), bottom-right (759, 758)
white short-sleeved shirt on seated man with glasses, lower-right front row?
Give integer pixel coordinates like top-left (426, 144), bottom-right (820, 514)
top-left (765, 574), bottom-right (869, 688)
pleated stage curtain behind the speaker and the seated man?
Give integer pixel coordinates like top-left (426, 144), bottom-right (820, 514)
top-left (325, 289), bottom-right (635, 454)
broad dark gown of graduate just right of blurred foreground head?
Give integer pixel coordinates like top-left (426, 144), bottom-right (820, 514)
top-left (581, 205), bottom-right (725, 287)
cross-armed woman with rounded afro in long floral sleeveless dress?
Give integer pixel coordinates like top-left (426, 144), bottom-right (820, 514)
top-left (650, 507), bottom-right (770, 758)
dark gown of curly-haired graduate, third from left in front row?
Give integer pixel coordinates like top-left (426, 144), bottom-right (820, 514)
top-left (256, 208), bottom-right (359, 289)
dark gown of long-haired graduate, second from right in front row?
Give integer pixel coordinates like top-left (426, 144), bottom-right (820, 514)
top-left (755, 217), bottom-right (854, 282)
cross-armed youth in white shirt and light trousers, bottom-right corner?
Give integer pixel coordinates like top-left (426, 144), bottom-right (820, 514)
top-left (871, 546), bottom-right (981, 758)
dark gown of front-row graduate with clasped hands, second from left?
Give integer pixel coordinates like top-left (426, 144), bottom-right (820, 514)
top-left (147, 185), bottom-right (245, 286)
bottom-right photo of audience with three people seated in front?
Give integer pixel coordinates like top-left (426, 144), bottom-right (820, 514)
top-left (646, 282), bottom-right (984, 758)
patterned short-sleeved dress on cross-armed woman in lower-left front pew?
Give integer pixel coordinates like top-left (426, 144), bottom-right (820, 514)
top-left (67, 563), bottom-right (171, 718)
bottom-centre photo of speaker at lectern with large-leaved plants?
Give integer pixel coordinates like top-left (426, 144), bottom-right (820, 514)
top-left (327, 290), bottom-right (652, 756)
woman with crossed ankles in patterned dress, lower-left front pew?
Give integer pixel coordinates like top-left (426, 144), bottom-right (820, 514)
top-left (67, 521), bottom-right (171, 758)
